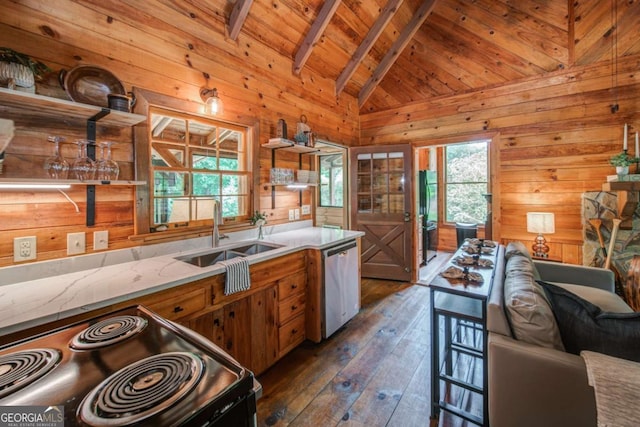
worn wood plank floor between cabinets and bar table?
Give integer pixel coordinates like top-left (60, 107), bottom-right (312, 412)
top-left (258, 251), bottom-right (476, 427)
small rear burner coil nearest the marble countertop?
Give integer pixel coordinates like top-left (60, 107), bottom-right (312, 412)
top-left (69, 316), bottom-right (147, 350)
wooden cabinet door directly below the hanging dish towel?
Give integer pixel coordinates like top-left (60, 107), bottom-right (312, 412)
top-left (223, 297), bottom-right (251, 366)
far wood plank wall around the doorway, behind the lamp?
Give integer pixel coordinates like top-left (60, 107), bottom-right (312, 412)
top-left (360, 55), bottom-right (640, 264)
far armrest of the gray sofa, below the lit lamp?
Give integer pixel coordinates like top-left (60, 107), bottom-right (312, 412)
top-left (533, 260), bottom-right (615, 292)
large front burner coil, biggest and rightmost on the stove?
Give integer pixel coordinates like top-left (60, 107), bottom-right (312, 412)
top-left (79, 352), bottom-right (204, 426)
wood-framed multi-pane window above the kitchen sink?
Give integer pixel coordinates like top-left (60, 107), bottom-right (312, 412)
top-left (150, 108), bottom-right (251, 226)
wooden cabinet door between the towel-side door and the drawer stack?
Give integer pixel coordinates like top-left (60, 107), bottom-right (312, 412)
top-left (250, 285), bottom-right (278, 375)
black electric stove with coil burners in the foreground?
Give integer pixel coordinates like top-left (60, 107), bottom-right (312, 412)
top-left (0, 306), bottom-right (260, 427)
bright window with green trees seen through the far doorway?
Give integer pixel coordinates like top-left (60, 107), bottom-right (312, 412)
top-left (444, 141), bottom-right (489, 224)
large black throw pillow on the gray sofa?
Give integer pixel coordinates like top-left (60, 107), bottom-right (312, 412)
top-left (538, 281), bottom-right (640, 362)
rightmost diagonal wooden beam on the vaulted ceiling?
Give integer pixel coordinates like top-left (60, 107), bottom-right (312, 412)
top-left (358, 0), bottom-right (437, 108)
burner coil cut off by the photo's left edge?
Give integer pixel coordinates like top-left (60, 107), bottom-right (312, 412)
top-left (0, 348), bottom-right (60, 398)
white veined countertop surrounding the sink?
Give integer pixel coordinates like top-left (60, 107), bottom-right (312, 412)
top-left (0, 226), bottom-right (364, 336)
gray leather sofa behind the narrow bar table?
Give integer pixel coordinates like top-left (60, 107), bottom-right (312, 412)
top-left (487, 243), bottom-right (632, 427)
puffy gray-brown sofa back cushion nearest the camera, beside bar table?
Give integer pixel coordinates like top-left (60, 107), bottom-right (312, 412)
top-left (504, 254), bottom-right (564, 350)
